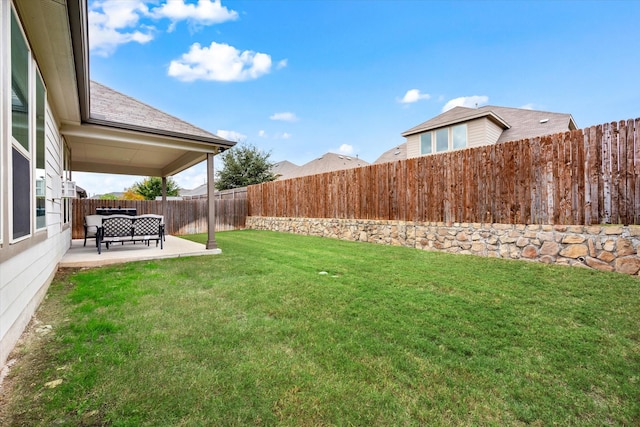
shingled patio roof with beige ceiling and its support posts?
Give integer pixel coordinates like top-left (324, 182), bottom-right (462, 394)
top-left (61, 81), bottom-right (235, 254)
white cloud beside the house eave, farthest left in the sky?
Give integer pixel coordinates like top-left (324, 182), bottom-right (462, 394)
top-left (89, 0), bottom-right (154, 56)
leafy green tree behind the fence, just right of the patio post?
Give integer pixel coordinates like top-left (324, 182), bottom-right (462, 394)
top-left (215, 144), bottom-right (276, 190)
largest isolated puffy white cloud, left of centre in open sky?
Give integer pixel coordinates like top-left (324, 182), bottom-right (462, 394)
top-left (168, 42), bottom-right (271, 82)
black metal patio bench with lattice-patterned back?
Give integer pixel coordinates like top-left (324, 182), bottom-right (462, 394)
top-left (96, 215), bottom-right (164, 254)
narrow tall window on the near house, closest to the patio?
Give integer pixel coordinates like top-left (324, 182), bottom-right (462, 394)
top-left (35, 73), bottom-right (47, 229)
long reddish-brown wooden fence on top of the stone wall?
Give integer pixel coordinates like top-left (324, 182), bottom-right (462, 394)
top-left (247, 119), bottom-right (640, 225)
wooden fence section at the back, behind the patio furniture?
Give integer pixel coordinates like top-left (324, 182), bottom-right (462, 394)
top-left (72, 198), bottom-right (247, 239)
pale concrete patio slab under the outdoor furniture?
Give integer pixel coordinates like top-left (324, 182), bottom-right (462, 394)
top-left (58, 236), bottom-right (222, 268)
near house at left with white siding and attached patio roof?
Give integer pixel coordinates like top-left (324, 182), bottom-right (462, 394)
top-left (0, 0), bottom-right (235, 366)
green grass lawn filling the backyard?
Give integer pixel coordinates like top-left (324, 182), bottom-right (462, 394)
top-left (0, 231), bottom-right (640, 426)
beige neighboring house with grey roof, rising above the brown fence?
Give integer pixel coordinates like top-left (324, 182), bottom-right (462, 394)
top-left (402, 106), bottom-right (577, 158)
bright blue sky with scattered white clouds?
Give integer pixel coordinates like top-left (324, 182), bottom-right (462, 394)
top-left (74, 0), bottom-right (640, 194)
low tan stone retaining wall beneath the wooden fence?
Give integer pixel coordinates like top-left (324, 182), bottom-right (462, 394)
top-left (246, 217), bottom-right (640, 275)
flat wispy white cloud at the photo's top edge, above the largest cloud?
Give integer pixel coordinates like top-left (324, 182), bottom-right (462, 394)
top-left (151, 0), bottom-right (238, 32)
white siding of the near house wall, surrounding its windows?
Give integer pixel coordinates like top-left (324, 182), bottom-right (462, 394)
top-left (0, 2), bottom-right (71, 366)
